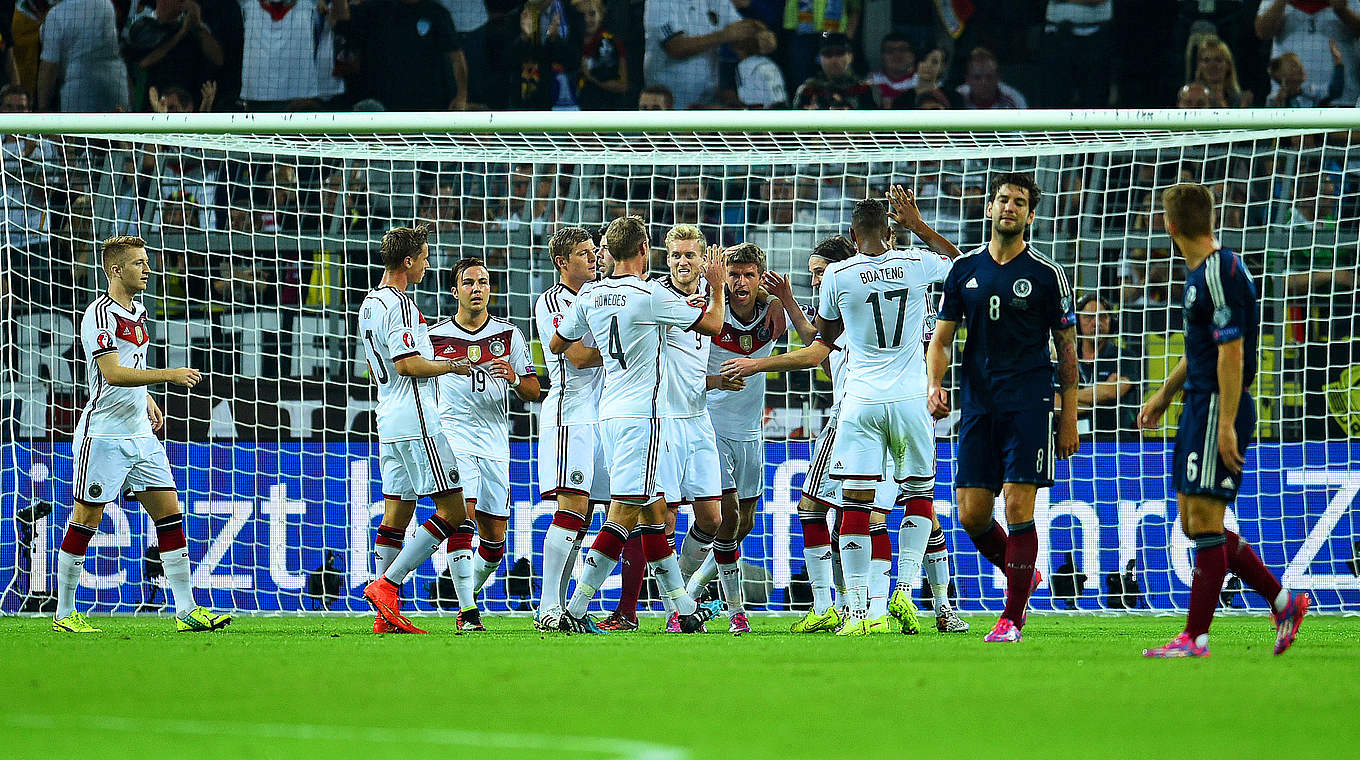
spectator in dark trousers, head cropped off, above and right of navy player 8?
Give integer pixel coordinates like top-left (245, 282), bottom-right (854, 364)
top-left (1039, 0), bottom-right (1114, 109)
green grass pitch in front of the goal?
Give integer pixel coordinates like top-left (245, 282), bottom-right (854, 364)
top-left (0, 616), bottom-right (1360, 760)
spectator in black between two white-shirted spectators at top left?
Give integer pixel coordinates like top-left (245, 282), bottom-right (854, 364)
top-left (122, 0), bottom-right (223, 106)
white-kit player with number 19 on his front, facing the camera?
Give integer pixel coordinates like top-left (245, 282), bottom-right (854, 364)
top-left (430, 258), bottom-right (539, 631)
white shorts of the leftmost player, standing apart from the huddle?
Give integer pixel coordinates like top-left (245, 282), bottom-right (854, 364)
top-left (71, 435), bottom-right (175, 504)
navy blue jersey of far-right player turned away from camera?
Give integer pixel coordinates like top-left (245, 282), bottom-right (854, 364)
top-left (1183, 249), bottom-right (1261, 393)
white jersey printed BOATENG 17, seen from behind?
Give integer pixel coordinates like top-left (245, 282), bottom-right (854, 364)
top-left (817, 247), bottom-right (952, 402)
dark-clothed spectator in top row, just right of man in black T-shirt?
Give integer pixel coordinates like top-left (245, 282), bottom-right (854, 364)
top-left (509, 0), bottom-right (582, 110)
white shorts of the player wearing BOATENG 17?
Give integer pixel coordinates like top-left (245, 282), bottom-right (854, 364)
top-left (830, 397), bottom-right (934, 488)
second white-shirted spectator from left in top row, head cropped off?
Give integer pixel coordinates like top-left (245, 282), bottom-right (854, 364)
top-left (241, 0), bottom-right (345, 111)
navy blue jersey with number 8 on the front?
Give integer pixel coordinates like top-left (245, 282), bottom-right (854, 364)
top-left (938, 245), bottom-right (1077, 415)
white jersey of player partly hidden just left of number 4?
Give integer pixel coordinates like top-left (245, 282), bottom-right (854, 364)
top-left (533, 283), bottom-right (604, 427)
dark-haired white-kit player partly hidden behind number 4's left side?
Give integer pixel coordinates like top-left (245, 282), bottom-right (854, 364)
top-left (533, 227), bottom-right (609, 631)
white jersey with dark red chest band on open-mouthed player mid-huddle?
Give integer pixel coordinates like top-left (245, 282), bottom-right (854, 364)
top-left (709, 296), bottom-right (779, 441)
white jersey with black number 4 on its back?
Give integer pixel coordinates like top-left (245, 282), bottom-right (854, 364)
top-left (558, 275), bottom-right (703, 420)
